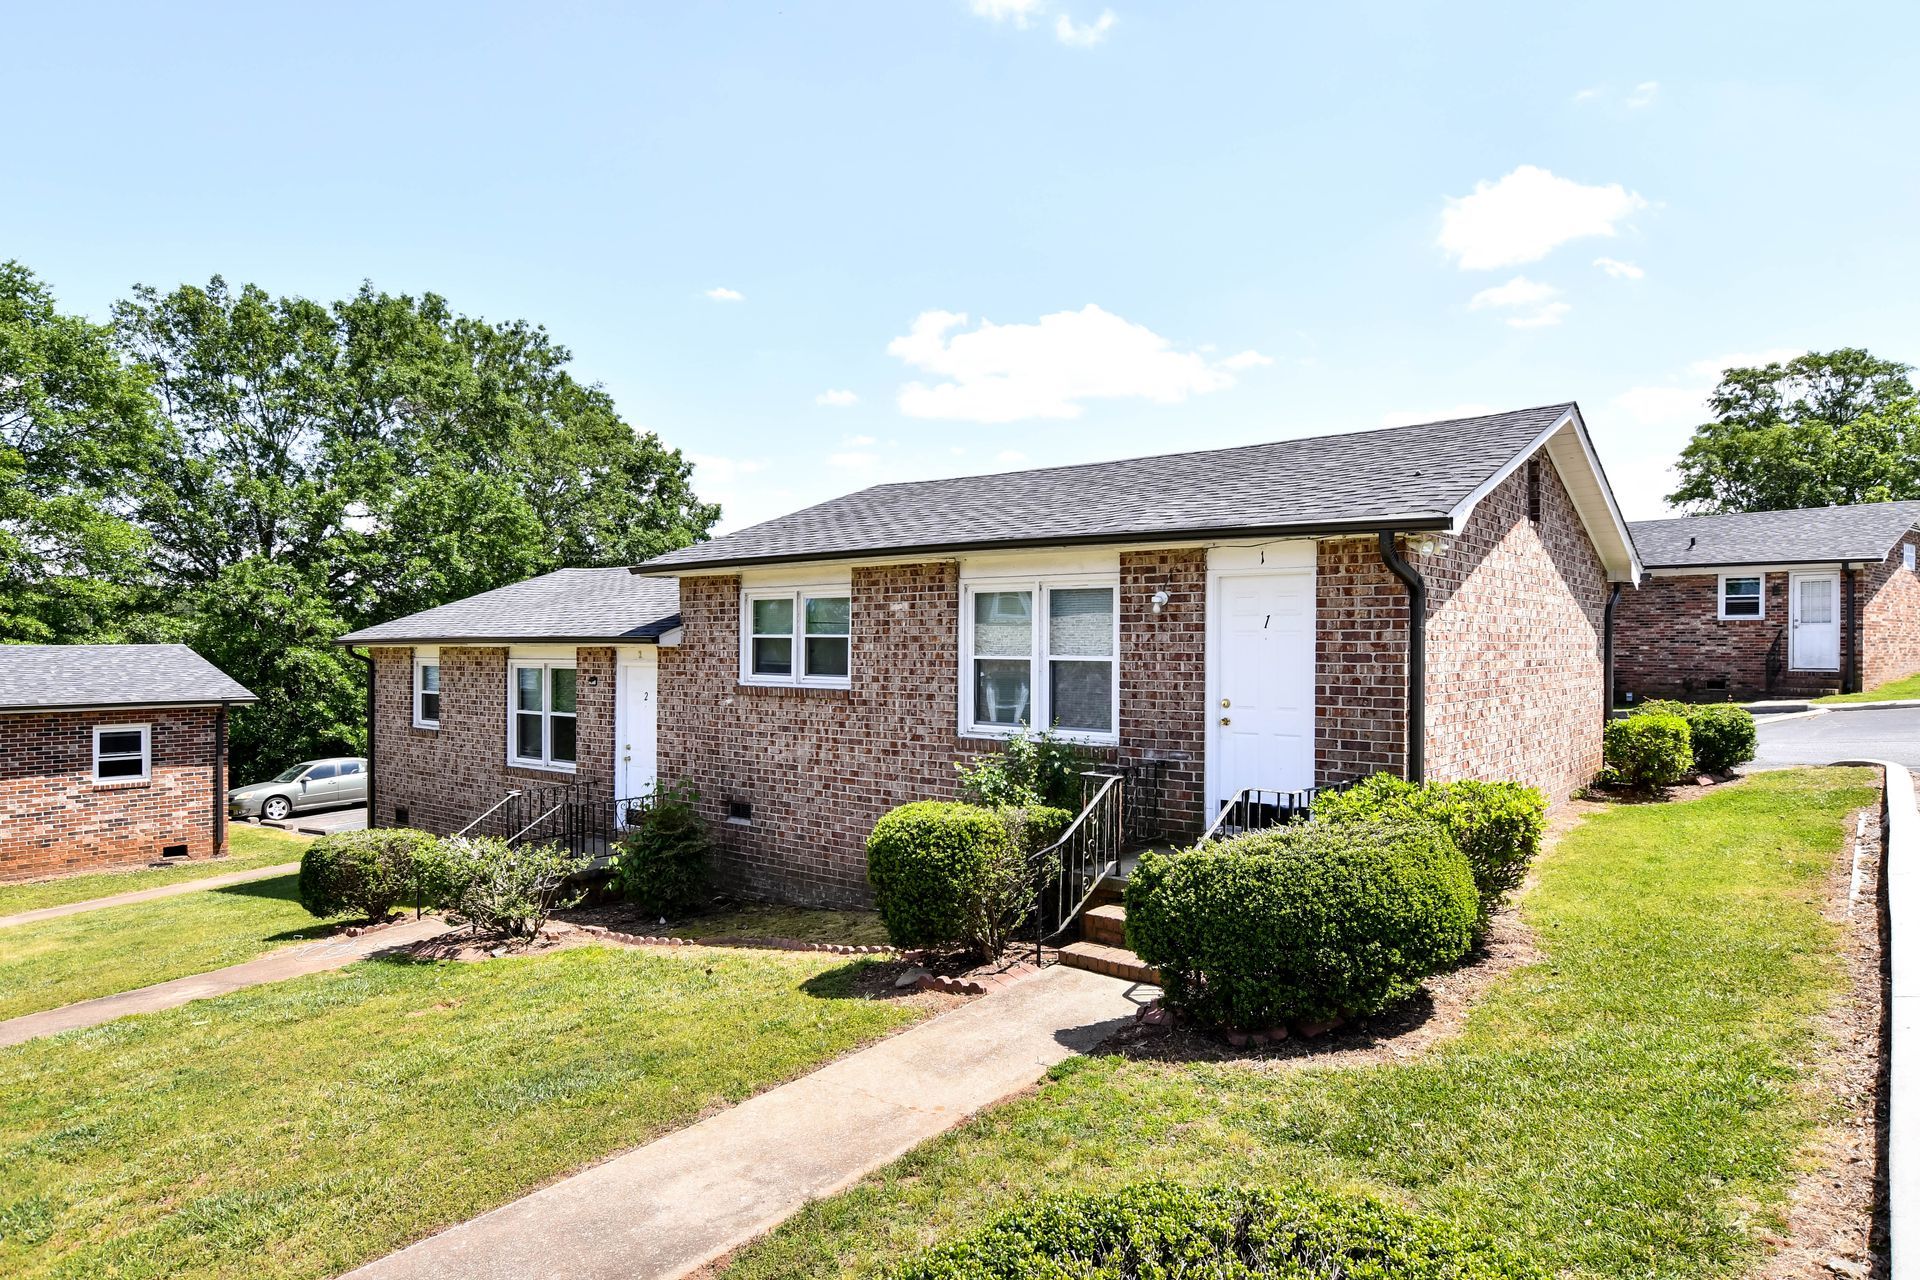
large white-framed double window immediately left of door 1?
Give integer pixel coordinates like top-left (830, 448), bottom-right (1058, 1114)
top-left (960, 580), bottom-right (1119, 743)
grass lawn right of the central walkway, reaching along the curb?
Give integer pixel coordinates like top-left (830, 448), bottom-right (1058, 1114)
top-left (726, 770), bottom-right (1878, 1280)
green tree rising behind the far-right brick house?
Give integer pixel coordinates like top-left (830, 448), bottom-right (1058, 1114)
top-left (1667, 347), bottom-right (1920, 512)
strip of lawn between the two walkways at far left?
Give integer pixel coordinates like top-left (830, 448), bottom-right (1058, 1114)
top-left (0, 875), bottom-right (341, 1017)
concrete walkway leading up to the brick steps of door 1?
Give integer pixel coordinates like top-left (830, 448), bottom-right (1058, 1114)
top-left (337, 965), bottom-right (1158, 1280)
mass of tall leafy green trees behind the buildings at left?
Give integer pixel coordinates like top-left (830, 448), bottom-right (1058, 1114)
top-left (0, 263), bottom-right (720, 770)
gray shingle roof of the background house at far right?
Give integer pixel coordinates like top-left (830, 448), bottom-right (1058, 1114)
top-left (1628, 503), bottom-right (1920, 568)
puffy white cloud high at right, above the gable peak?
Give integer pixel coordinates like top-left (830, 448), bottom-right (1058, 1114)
top-left (1440, 165), bottom-right (1647, 271)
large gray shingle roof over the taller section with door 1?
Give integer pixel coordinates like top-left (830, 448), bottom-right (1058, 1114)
top-left (636, 405), bottom-right (1572, 572)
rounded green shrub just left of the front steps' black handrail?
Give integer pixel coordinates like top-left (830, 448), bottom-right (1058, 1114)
top-left (866, 800), bottom-right (1031, 958)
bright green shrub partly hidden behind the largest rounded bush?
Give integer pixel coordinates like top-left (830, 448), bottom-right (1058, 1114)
top-left (1313, 773), bottom-right (1548, 931)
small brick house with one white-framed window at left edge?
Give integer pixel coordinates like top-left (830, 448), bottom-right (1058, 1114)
top-left (0, 645), bottom-right (253, 881)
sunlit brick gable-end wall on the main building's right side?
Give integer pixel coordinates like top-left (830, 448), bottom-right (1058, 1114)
top-left (1413, 455), bottom-right (1607, 800)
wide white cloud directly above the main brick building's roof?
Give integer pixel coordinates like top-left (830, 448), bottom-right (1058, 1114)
top-left (887, 303), bottom-right (1259, 422)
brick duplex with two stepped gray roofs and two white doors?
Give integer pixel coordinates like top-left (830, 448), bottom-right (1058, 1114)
top-left (344, 405), bottom-right (1638, 904)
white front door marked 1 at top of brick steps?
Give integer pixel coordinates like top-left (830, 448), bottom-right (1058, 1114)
top-left (1208, 570), bottom-right (1313, 812)
